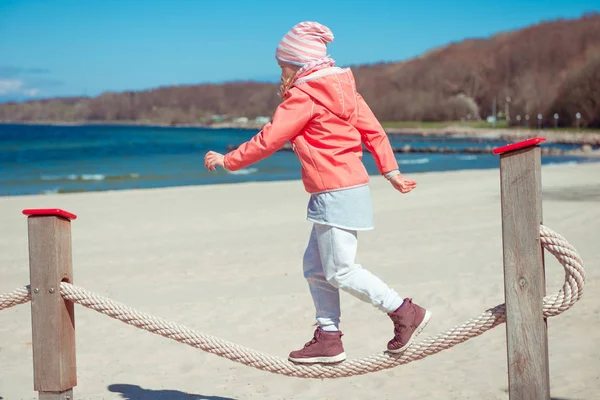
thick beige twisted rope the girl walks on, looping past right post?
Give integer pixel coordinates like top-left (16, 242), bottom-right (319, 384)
top-left (0, 225), bottom-right (585, 379)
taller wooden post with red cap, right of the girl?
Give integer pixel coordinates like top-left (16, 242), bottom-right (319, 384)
top-left (494, 138), bottom-right (550, 400)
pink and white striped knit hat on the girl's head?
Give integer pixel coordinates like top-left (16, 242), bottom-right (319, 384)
top-left (275, 21), bottom-right (333, 66)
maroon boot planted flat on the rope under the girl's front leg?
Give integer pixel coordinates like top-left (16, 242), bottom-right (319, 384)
top-left (288, 327), bottom-right (346, 364)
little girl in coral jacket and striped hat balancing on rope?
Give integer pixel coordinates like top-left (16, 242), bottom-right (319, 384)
top-left (204, 22), bottom-right (431, 363)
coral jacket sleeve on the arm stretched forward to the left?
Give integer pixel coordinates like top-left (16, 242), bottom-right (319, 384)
top-left (223, 90), bottom-right (312, 171)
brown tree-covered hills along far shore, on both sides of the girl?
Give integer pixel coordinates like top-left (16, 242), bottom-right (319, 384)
top-left (0, 13), bottom-right (600, 127)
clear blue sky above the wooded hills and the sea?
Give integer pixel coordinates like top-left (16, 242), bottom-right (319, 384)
top-left (0, 0), bottom-right (600, 101)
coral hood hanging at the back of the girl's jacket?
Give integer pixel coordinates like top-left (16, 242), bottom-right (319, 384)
top-left (294, 67), bottom-right (356, 120)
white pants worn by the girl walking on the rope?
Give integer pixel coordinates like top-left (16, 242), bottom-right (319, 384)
top-left (303, 224), bottom-right (403, 330)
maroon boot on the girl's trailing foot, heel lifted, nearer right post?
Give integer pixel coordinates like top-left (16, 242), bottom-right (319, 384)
top-left (388, 298), bottom-right (431, 354)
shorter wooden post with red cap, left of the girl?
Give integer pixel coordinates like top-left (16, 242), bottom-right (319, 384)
top-left (23, 209), bottom-right (77, 400)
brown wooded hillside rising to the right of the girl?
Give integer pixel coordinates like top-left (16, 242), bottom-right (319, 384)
top-left (356, 13), bottom-right (600, 126)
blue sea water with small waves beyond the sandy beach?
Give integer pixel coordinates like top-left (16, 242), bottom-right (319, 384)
top-left (0, 124), bottom-right (591, 196)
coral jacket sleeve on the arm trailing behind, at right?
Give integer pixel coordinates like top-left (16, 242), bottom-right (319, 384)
top-left (354, 93), bottom-right (398, 175)
